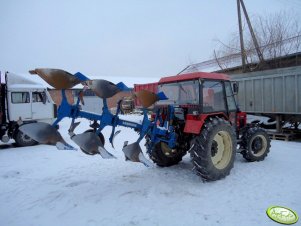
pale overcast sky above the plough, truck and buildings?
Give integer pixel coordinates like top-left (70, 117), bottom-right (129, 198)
top-left (0, 0), bottom-right (301, 80)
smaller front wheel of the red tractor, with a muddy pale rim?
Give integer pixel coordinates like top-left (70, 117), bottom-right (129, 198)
top-left (241, 127), bottom-right (271, 162)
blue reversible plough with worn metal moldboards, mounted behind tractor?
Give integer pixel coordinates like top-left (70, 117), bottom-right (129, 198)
top-left (20, 68), bottom-right (175, 166)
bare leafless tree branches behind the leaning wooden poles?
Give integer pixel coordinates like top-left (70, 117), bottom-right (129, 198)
top-left (214, 11), bottom-right (301, 70)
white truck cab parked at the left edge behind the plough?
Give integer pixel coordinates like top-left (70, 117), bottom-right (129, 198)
top-left (0, 72), bottom-right (57, 146)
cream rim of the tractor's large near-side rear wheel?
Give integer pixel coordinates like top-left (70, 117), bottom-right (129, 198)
top-left (211, 131), bottom-right (233, 169)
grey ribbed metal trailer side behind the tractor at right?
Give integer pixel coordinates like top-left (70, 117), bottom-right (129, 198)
top-left (230, 66), bottom-right (301, 114)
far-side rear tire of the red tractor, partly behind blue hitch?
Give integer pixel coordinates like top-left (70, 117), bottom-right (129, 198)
top-left (149, 141), bottom-right (186, 167)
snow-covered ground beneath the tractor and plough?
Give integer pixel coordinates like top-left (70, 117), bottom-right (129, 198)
top-left (0, 116), bottom-right (301, 226)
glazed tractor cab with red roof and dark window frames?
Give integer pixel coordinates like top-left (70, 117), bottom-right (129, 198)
top-left (157, 72), bottom-right (237, 124)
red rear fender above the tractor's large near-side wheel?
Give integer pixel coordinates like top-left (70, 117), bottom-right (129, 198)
top-left (184, 112), bottom-right (228, 134)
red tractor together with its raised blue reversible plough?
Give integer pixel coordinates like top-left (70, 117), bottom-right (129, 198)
top-left (20, 69), bottom-right (270, 181)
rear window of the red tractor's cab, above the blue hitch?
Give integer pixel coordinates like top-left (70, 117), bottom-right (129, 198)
top-left (158, 80), bottom-right (199, 104)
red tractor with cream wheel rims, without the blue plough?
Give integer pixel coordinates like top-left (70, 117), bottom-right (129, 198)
top-left (146, 72), bottom-right (270, 181)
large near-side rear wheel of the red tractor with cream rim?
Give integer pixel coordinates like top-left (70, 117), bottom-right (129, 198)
top-left (191, 118), bottom-right (236, 181)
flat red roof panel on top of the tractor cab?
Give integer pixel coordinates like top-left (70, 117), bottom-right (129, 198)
top-left (159, 72), bottom-right (229, 84)
